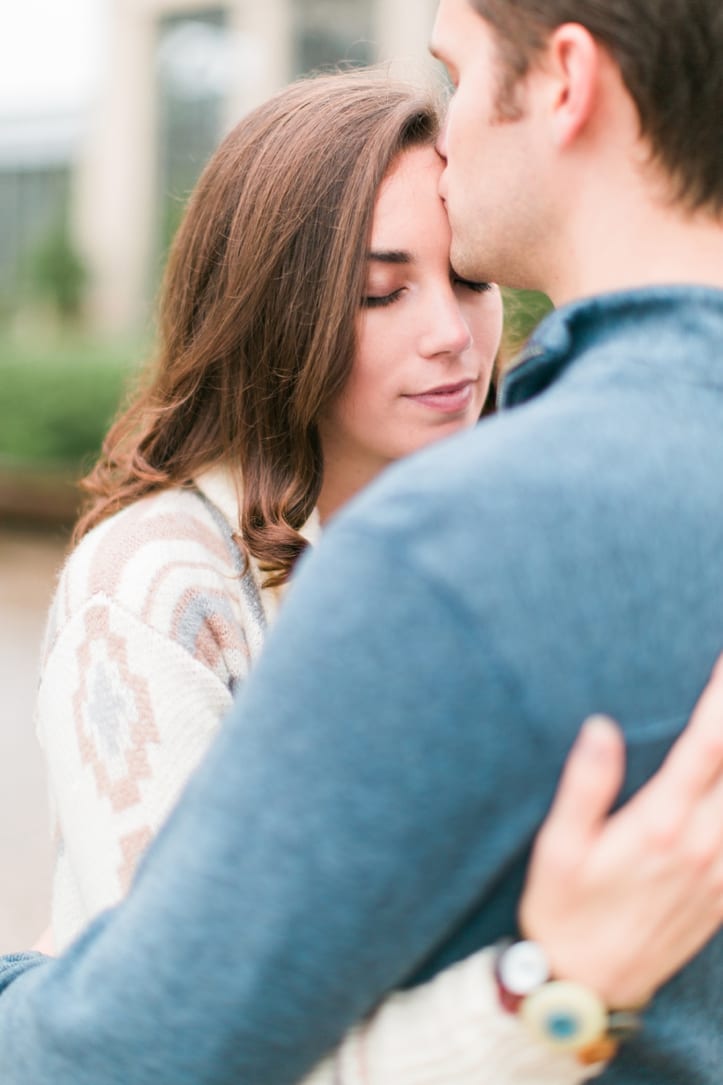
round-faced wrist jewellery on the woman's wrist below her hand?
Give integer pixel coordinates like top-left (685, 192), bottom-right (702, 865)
top-left (495, 941), bottom-right (642, 1065)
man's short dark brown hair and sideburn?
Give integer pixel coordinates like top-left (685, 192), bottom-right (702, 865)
top-left (470, 0), bottom-right (723, 214)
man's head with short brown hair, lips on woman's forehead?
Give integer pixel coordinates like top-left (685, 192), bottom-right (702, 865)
top-left (432, 0), bottom-right (723, 299)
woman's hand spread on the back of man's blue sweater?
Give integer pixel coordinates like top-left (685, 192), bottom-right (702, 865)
top-left (520, 656), bottom-right (723, 1007)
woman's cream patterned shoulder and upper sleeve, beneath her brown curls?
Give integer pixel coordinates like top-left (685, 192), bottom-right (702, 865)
top-left (36, 492), bottom-right (257, 948)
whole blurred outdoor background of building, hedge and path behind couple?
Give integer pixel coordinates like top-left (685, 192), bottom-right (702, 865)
top-left (0, 0), bottom-right (547, 952)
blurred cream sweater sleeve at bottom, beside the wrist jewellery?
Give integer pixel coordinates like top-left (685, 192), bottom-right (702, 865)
top-left (303, 949), bottom-right (601, 1085)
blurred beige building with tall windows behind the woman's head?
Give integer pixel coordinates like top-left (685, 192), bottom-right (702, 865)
top-left (19, 0), bottom-right (436, 333)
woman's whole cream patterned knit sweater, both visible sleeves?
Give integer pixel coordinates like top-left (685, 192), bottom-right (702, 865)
top-left (37, 468), bottom-right (591, 1085)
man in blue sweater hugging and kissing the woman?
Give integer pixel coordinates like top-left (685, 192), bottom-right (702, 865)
top-left (0, 0), bottom-right (723, 1085)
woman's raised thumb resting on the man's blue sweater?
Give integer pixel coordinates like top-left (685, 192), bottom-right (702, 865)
top-left (545, 716), bottom-right (625, 841)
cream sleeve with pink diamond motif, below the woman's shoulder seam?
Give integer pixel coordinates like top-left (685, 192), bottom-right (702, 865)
top-left (38, 596), bottom-right (231, 948)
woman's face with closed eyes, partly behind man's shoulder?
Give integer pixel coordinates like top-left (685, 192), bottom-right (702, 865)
top-left (319, 148), bottom-right (503, 488)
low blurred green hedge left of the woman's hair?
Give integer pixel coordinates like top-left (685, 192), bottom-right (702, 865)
top-left (0, 339), bottom-right (139, 475)
